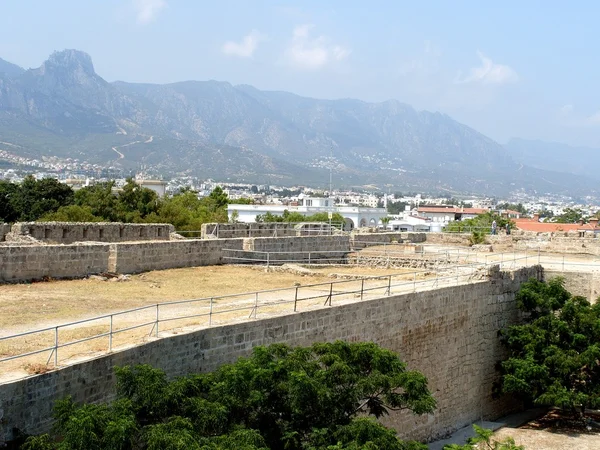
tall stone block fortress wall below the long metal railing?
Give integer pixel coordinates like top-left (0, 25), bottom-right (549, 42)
top-left (0, 267), bottom-right (541, 441)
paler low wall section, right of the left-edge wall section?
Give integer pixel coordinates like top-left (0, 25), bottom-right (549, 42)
top-left (109, 239), bottom-right (243, 273)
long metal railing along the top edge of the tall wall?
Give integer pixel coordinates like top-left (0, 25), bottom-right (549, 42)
top-left (0, 249), bottom-right (600, 374)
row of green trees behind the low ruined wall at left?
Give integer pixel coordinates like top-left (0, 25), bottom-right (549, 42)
top-left (0, 177), bottom-right (229, 231)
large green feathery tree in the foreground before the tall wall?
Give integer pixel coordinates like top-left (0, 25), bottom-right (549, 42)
top-left (23, 342), bottom-right (435, 450)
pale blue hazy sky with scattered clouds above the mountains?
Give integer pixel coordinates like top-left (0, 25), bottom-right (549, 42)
top-left (0, 0), bottom-right (600, 148)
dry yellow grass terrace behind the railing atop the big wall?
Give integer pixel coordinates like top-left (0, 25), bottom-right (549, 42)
top-left (0, 266), bottom-right (422, 378)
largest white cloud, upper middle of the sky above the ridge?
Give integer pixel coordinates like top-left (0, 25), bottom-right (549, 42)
top-left (285, 24), bottom-right (350, 69)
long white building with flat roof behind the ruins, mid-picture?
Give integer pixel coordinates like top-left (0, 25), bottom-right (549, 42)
top-left (227, 196), bottom-right (387, 230)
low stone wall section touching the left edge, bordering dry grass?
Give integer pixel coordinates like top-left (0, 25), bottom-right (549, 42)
top-left (0, 244), bottom-right (109, 282)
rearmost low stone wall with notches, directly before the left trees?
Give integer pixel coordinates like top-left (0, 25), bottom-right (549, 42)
top-left (6, 222), bottom-right (175, 244)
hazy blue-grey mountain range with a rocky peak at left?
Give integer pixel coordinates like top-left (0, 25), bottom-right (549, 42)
top-left (0, 50), bottom-right (595, 194)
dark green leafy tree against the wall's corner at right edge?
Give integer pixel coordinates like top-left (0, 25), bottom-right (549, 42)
top-left (501, 278), bottom-right (600, 414)
